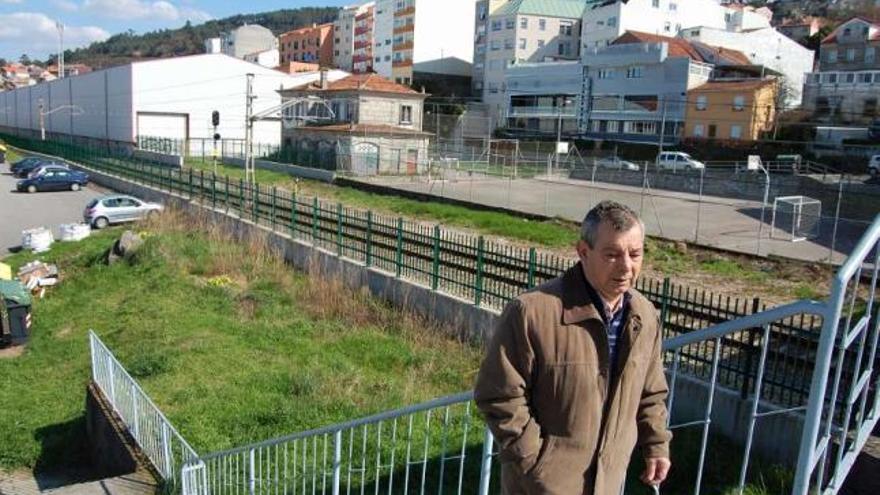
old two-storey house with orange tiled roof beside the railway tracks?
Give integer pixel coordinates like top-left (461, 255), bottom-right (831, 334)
top-left (281, 74), bottom-right (431, 175)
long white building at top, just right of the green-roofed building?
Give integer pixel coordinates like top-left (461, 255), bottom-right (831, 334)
top-left (581, 0), bottom-right (770, 49)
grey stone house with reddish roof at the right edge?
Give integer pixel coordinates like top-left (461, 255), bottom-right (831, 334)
top-left (804, 17), bottom-right (880, 124)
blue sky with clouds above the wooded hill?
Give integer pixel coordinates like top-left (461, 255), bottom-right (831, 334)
top-left (0, 0), bottom-right (357, 60)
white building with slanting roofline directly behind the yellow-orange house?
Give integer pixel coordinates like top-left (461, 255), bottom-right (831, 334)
top-left (681, 27), bottom-right (815, 108)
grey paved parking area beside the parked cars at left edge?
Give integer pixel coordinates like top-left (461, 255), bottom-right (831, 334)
top-left (0, 164), bottom-right (105, 258)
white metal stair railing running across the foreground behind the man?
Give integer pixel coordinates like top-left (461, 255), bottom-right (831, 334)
top-left (91, 216), bottom-right (880, 495)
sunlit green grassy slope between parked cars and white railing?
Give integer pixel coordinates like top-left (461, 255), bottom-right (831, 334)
top-left (0, 222), bottom-right (479, 470)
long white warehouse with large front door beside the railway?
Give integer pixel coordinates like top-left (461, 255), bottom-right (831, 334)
top-left (0, 54), bottom-right (348, 145)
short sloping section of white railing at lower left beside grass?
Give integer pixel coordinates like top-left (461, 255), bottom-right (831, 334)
top-left (89, 331), bottom-right (198, 490)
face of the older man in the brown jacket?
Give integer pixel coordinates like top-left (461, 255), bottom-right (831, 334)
top-left (577, 222), bottom-right (644, 304)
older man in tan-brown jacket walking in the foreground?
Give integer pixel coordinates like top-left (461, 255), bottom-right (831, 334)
top-left (474, 201), bottom-right (672, 495)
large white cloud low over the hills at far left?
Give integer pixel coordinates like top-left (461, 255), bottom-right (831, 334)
top-left (0, 12), bottom-right (110, 56)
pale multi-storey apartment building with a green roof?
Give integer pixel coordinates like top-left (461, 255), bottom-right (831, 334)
top-left (473, 0), bottom-right (584, 122)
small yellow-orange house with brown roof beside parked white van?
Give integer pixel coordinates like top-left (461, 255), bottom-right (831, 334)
top-left (684, 79), bottom-right (778, 141)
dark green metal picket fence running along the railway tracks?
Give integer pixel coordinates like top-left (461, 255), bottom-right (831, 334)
top-left (4, 136), bottom-right (832, 406)
